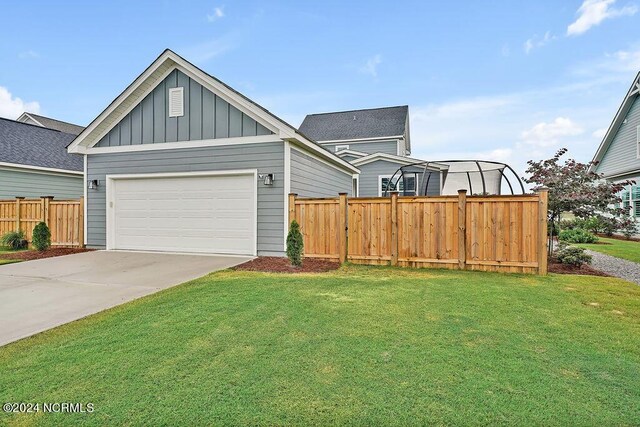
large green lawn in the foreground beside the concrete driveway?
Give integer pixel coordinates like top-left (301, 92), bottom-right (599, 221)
top-left (0, 266), bottom-right (640, 425)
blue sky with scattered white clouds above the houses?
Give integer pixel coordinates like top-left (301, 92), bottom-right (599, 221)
top-left (0, 0), bottom-right (640, 176)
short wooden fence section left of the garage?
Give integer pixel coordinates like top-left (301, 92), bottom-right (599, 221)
top-left (0, 197), bottom-right (84, 247)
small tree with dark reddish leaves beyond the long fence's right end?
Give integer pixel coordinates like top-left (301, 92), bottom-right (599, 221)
top-left (524, 148), bottom-right (634, 251)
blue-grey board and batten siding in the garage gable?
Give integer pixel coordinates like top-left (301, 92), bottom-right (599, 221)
top-left (96, 70), bottom-right (273, 147)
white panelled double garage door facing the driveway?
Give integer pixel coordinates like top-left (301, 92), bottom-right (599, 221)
top-left (107, 174), bottom-right (256, 255)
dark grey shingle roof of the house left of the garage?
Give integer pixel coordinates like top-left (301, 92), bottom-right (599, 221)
top-left (0, 118), bottom-right (84, 172)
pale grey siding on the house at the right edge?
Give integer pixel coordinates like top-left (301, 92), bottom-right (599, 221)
top-left (596, 96), bottom-right (640, 177)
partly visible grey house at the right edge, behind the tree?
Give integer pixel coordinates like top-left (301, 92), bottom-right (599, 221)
top-left (592, 73), bottom-right (640, 229)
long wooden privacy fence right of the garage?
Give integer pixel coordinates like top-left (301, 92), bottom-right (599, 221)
top-left (289, 190), bottom-right (548, 274)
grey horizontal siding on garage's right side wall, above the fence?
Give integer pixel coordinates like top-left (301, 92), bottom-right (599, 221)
top-left (291, 148), bottom-right (353, 197)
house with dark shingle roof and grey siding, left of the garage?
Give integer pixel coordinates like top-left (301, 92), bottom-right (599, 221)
top-left (0, 114), bottom-right (84, 199)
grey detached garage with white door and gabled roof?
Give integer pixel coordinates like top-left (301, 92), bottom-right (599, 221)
top-left (68, 50), bottom-right (359, 256)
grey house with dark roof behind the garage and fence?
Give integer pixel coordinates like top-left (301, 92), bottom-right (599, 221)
top-left (300, 105), bottom-right (447, 197)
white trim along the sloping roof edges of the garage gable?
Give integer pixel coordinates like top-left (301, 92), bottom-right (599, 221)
top-left (67, 49), bottom-right (359, 173)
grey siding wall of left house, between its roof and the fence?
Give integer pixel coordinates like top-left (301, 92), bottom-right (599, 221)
top-left (0, 168), bottom-right (84, 200)
